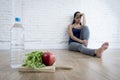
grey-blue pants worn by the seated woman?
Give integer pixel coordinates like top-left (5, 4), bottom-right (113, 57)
top-left (69, 26), bottom-right (95, 56)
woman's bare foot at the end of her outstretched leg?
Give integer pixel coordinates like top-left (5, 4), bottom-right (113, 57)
top-left (95, 42), bottom-right (109, 58)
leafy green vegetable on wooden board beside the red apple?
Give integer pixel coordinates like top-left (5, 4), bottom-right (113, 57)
top-left (23, 51), bottom-right (45, 70)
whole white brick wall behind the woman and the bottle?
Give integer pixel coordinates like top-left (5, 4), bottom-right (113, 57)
top-left (0, 0), bottom-right (120, 49)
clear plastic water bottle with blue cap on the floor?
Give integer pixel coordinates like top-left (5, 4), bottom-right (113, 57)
top-left (10, 18), bottom-right (24, 68)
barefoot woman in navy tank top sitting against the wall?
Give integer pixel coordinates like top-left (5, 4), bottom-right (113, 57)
top-left (68, 12), bottom-right (109, 58)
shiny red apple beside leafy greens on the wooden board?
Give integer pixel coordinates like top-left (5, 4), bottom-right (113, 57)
top-left (42, 52), bottom-right (56, 66)
